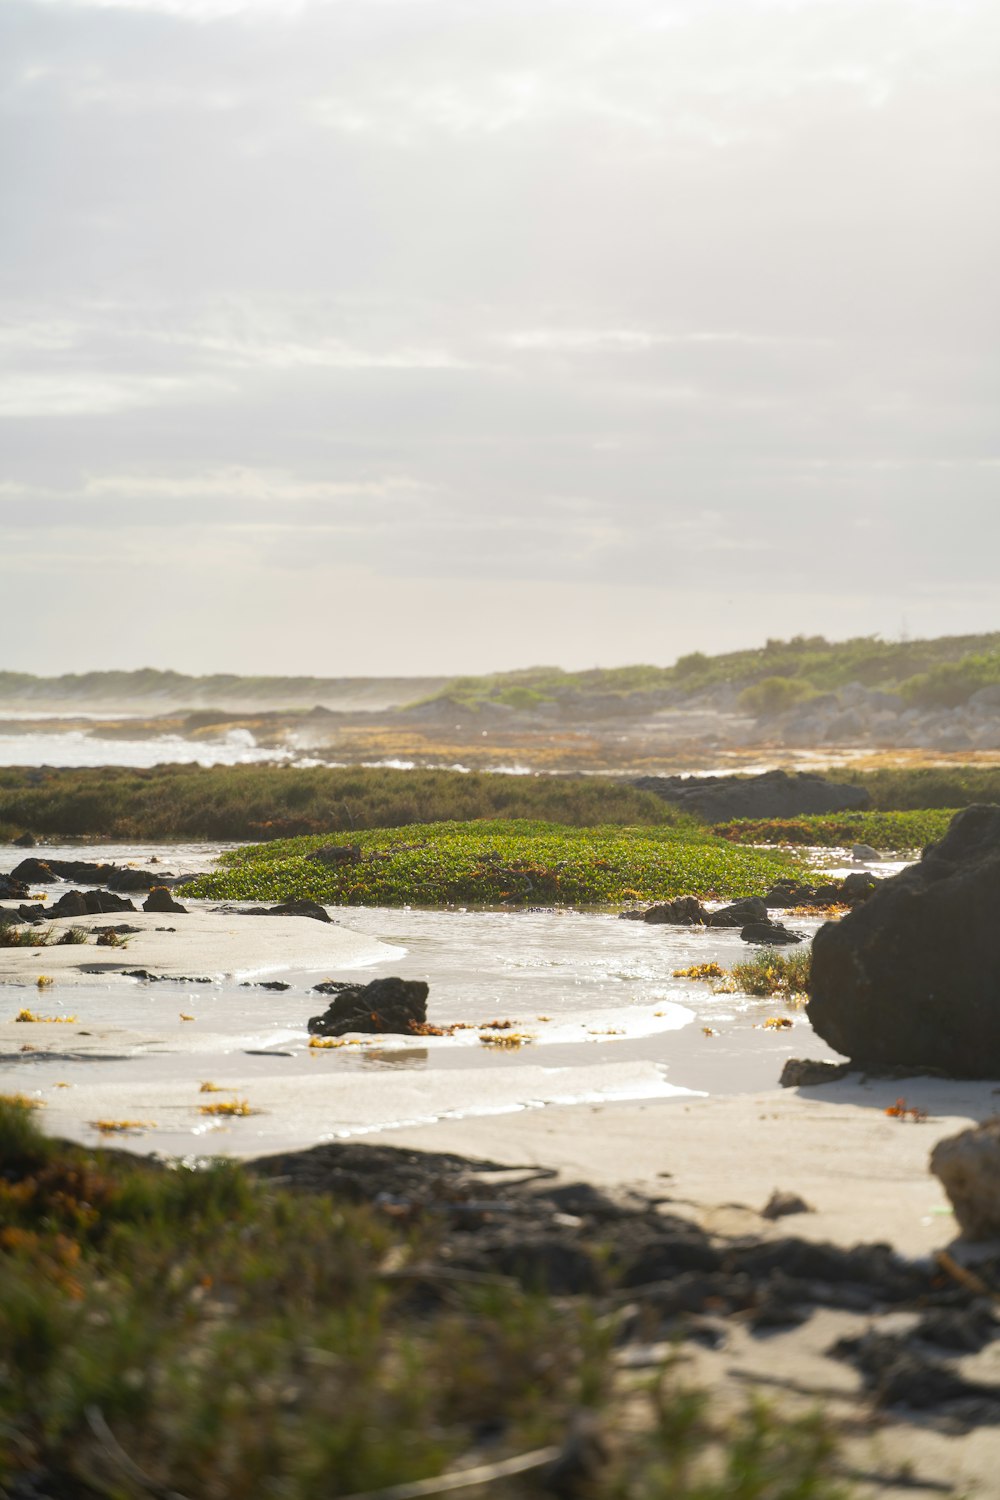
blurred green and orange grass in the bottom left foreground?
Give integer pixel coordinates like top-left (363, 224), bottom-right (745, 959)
top-left (0, 1097), bottom-right (849, 1500)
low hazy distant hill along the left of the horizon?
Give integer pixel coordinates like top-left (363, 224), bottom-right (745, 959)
top-left (0, 668), bottom-right (447, 713)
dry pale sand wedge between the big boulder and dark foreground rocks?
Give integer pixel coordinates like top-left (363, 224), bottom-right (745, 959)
top-left (361, 1079), bottom-right (1000, 1257)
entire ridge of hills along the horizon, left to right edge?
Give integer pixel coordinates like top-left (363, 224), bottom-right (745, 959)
top-left (7, 632), bottom-right (1000, 720)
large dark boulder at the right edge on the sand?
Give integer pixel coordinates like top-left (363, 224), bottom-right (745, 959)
top-left (808, 806), bottom-right (1000, 1079)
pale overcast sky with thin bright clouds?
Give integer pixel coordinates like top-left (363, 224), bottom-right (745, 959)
top-left (0, 0), bottom-right (1000, 675)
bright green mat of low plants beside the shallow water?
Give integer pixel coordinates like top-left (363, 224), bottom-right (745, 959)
top-left (184, 821), bottom-right (792, 906)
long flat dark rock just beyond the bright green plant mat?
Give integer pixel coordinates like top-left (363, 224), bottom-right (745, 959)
top-left (633, 771), bottom-right (871, 824)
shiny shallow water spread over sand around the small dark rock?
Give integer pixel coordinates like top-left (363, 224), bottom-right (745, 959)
top-left (0, 843), bottom-right (863, 1155)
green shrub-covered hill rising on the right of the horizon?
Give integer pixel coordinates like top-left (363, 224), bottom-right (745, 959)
top-left (414, 632), bottom-right (1000, 714)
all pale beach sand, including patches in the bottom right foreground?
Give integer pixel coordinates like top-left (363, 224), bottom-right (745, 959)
top-left (7, 911), bottom-right (1000, 1497)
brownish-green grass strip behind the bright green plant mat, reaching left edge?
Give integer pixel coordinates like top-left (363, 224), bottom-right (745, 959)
top-left (0, 765), bottom-right (682, 842)
